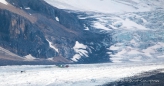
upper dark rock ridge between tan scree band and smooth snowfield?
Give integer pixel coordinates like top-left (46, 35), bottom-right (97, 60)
top-left (7, 0), bottom-right (84, 31)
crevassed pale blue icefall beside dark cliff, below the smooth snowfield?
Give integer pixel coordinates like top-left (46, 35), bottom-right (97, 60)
top-left (78, 9), bottom-right (164, 62)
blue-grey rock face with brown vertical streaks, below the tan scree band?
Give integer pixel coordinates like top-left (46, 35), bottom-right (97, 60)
top-left (0, 10), bottom-right (55, 58)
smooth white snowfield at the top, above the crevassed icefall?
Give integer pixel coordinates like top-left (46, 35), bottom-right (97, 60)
top-left (45, 0), bottom-right (164, 13)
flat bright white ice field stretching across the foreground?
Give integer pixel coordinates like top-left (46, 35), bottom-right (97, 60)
top-left (0, 63), bottom-right (164, 86)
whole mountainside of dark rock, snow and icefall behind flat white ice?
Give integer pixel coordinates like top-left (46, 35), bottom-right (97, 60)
top-left (0, 0), bottom-right (164, 63)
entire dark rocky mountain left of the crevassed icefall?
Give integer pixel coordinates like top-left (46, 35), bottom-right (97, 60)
top-left (0, 0), bottom-right (111, 63)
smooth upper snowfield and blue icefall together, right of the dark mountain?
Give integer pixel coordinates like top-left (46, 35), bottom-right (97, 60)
top-left (45, 0), bottom-right (164, 62)
